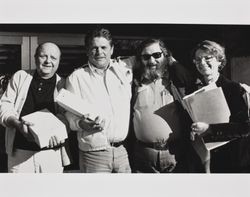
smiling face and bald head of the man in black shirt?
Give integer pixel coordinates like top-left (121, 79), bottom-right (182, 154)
top-left (35, 43), bottom-right (61, 79)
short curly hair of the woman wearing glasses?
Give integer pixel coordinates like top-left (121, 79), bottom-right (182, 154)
top-left (191, 40), bottom-right (227, 71)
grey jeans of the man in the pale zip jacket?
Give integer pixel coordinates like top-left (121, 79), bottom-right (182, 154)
top-left (79, 145), bottom-right (131, 173)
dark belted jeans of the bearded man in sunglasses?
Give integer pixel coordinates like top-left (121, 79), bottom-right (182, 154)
top-left (134, 142), bottom-right (176, 173)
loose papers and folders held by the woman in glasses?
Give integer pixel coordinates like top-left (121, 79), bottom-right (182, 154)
top-left (182, 84), bottom-right (230, 161)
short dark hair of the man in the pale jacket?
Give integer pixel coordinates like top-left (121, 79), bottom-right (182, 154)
top-left (85, 28), bottom-right (113, 48)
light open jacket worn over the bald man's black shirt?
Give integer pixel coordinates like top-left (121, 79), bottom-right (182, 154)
top-left (0, 70), bottom-right (71, 166)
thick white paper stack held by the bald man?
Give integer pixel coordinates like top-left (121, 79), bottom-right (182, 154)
top-left (22, 109), bottom-right (68, 148)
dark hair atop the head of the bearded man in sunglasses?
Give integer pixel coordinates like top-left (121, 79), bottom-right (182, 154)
top-left (136, 38), bottom-right (172, 60)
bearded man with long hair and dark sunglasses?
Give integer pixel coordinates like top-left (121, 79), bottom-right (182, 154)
top-left (132, 39), bottom-right (194, 173)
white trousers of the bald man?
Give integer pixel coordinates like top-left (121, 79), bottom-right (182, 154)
top-left (8, 149), bottom-right (63, 173)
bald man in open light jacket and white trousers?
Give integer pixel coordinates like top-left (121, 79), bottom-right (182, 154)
top-left (0, 42), bottom-right (70, 173)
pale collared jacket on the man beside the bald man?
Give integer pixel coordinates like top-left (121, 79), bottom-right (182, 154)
top-left (66, 61), bottom-right (132, 151)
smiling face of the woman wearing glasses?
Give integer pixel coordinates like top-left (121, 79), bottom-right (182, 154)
top-left (194, 49), bottom-right (221, 80)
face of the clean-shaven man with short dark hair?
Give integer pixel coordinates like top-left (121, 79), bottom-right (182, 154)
top-left (88, 37), bottom-right (113, 70)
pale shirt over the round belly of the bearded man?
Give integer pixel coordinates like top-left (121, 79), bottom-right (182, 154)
top-left (133, 79), bottom-right (180, 142)
